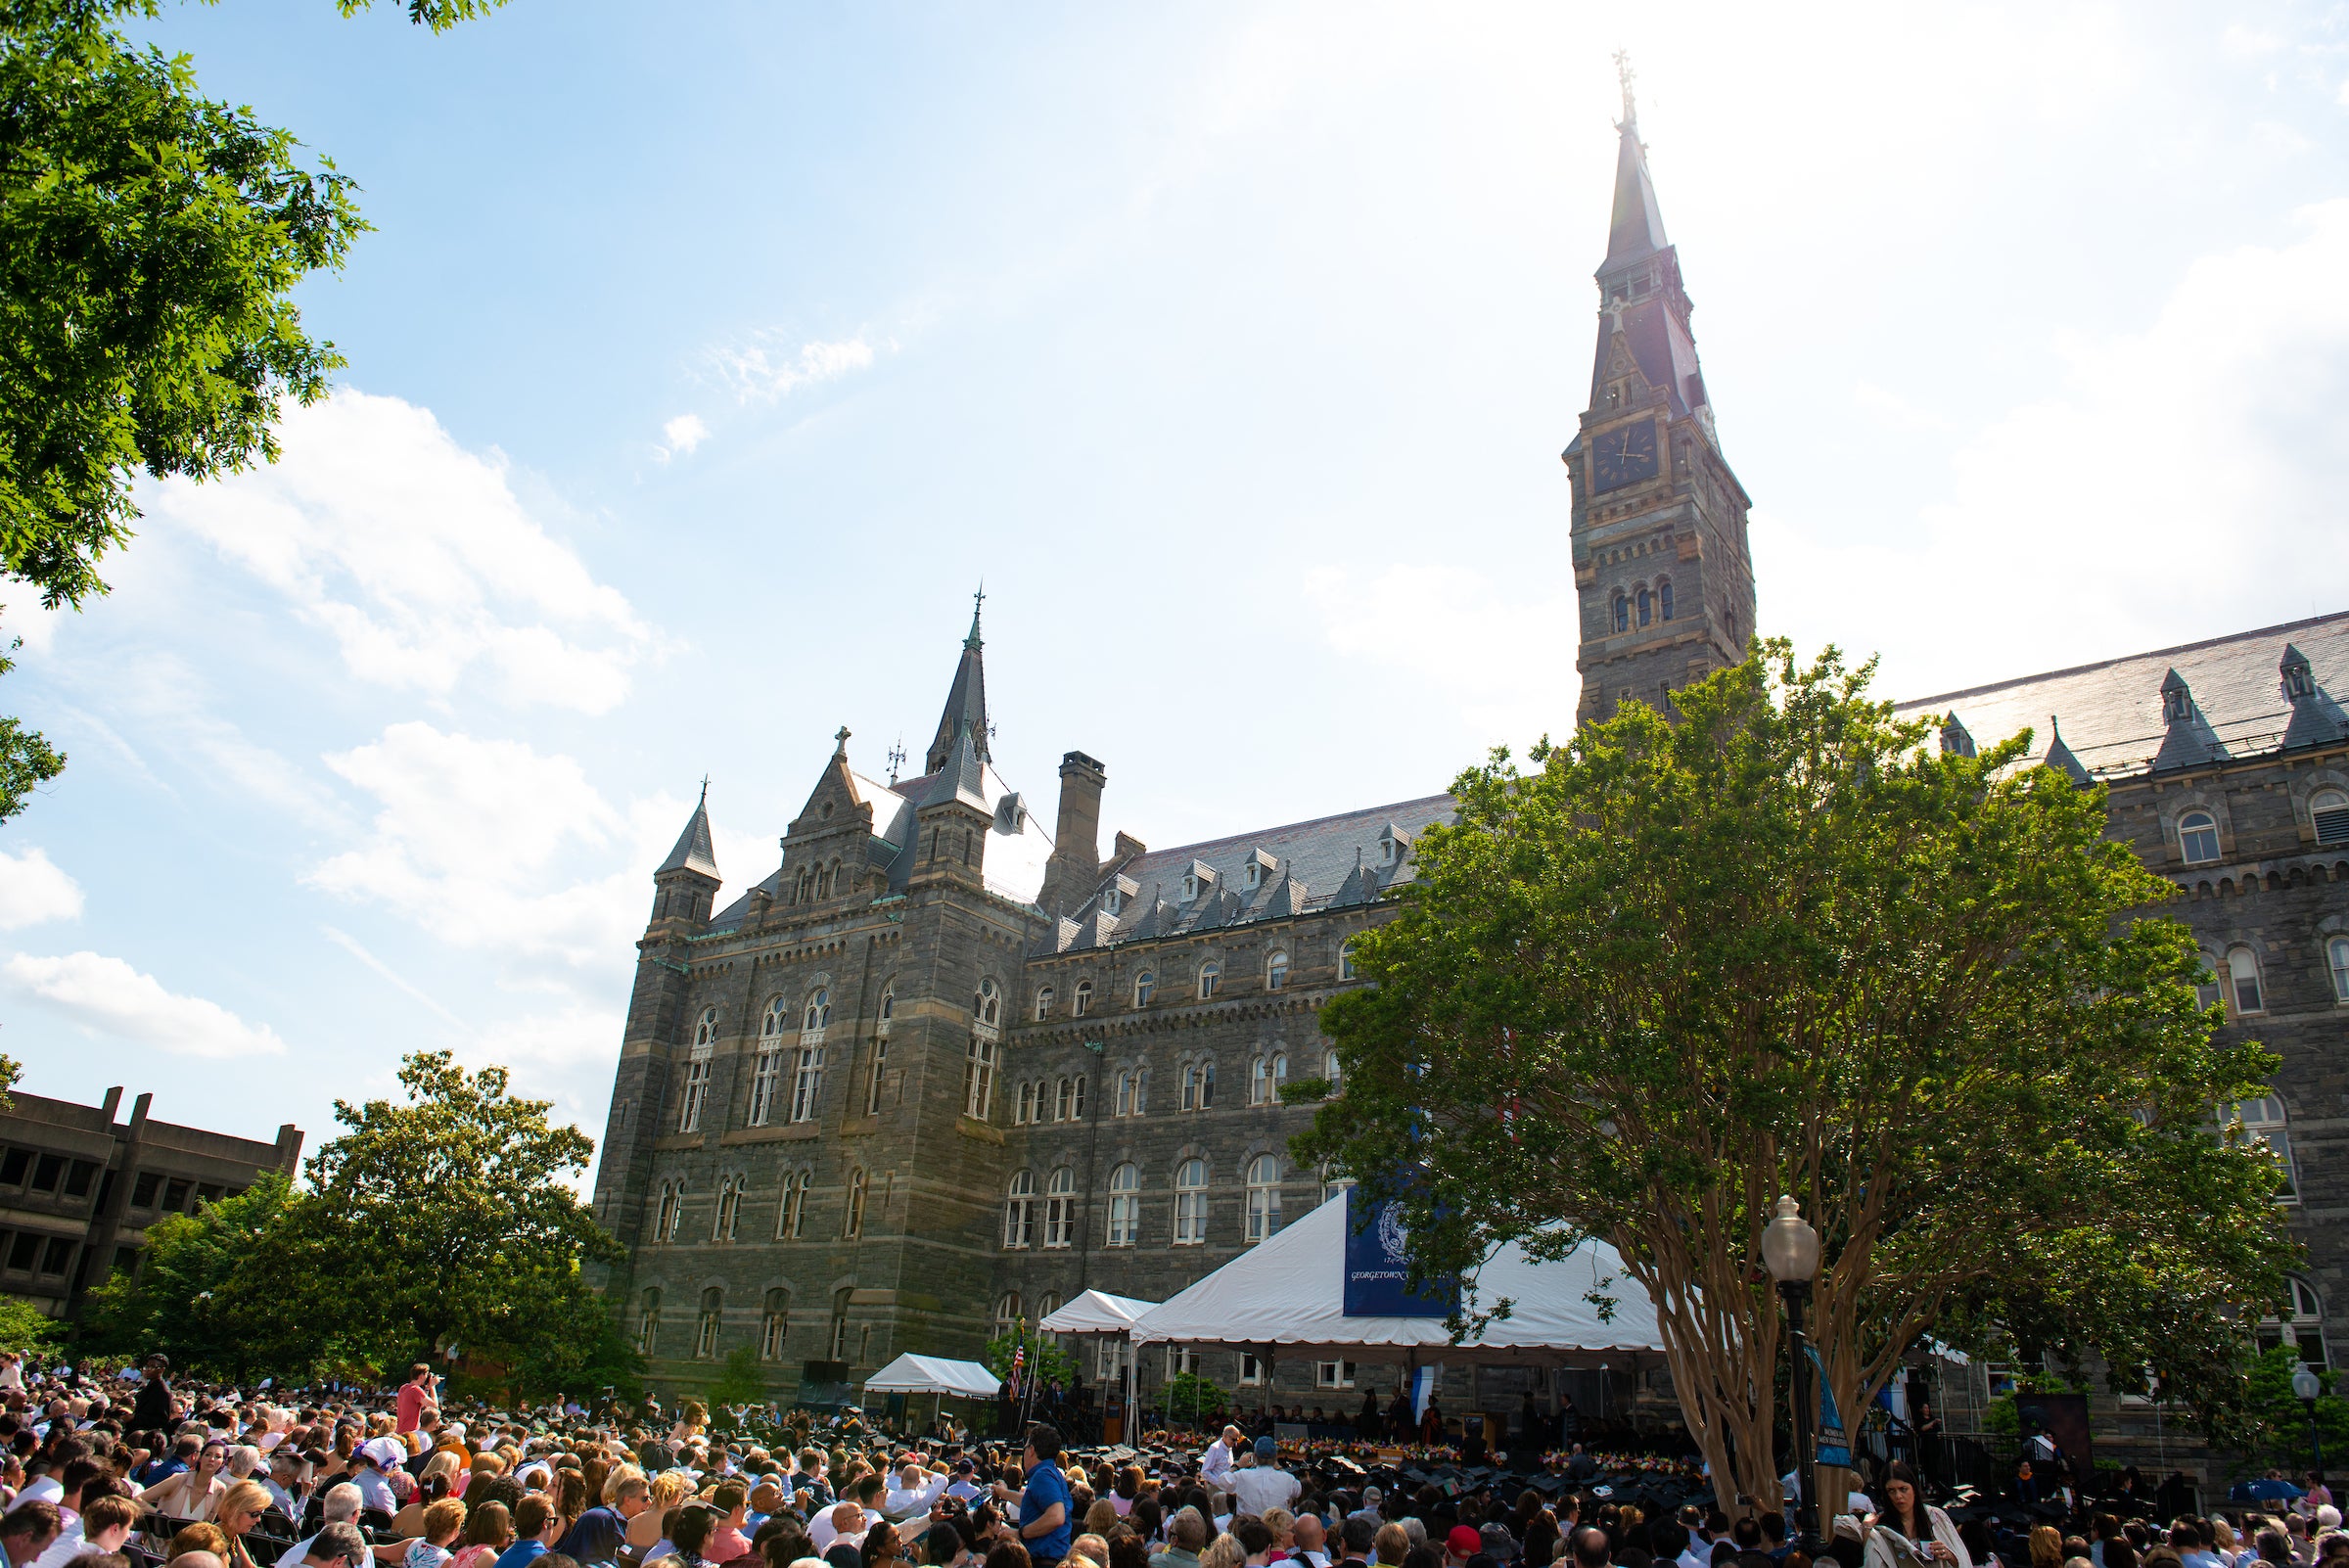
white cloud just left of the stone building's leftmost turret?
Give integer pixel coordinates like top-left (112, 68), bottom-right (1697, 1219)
top-left (305, 723), bottom-right (688, 984)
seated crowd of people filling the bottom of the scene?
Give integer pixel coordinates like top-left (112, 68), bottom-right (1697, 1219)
top-left (0, 1357), bottom-right (2349, 1568)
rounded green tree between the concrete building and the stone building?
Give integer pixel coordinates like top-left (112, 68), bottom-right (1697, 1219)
top-left (225, 1051), bottom-right (622, 1380)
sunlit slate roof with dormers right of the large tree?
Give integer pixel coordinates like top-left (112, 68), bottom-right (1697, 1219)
top-left (1898, 611), bottom-right (2349, 779)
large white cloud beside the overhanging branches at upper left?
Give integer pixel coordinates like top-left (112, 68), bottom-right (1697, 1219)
top-left (151, 392), bottom-right (653, 714)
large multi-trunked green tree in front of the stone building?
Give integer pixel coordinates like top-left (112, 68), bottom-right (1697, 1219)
top-left (1294, 643), bottom-right (2288, 1507)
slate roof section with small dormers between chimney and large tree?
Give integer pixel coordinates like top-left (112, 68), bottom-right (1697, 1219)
top-left (1057, 796), bottom-right (1451, 953)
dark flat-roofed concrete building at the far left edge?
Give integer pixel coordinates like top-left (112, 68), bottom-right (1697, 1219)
top-left (0, 1086), bottom-right (303, 1316)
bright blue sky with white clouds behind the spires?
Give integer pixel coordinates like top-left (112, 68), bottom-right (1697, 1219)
top-left (0, 0), bottom-right (2349, 1174)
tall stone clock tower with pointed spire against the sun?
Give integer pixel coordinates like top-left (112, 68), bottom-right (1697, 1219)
top-left (1564, 69), bottom-right (1755, 723)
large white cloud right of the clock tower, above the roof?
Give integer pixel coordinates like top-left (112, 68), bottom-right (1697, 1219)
top-left (1755, 200), bottom-right (2349, 695)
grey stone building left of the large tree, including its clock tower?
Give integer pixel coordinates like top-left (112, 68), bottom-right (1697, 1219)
top-left (594, 106), bottom-right (1752, 1404)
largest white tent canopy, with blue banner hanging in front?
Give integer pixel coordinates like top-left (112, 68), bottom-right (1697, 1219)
top-left (1134, 1192), bottom-right (1663, 1363)
